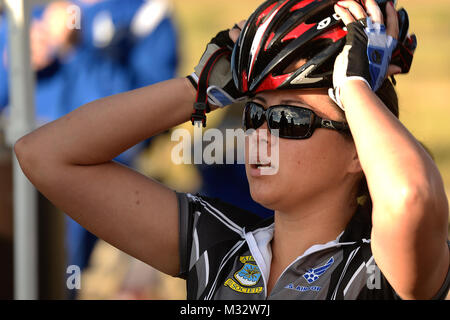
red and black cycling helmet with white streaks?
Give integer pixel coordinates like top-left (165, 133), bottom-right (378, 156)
top-left (232, 0), bottom-right (347, 94)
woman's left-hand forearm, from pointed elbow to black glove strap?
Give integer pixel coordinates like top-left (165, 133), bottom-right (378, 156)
top-left (16, 78), bottom-right (195, 165)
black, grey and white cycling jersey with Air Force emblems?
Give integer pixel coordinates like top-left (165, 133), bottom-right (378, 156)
top-left (177, 193), bottom-right (450, 300)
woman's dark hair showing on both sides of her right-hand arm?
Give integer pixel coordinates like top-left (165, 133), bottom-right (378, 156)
top-left (357, 79), bottom-right (400, 210)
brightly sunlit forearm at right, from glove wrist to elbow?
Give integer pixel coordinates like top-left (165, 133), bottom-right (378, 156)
top-left (342, 81), bottom-right (444, 210)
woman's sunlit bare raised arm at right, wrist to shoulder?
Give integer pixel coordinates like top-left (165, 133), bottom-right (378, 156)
top-left (341, 0), bottom-right (449, 299)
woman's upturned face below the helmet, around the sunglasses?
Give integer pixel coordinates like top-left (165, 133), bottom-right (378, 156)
top-left (246, 89), bottom-right (359, 211)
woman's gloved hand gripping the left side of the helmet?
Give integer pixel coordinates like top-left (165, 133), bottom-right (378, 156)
top-left (188, 21), bottom-right (245, 109)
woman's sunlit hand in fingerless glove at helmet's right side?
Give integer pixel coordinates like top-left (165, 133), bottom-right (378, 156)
top-left (330, 1), bottom-right (401, 109)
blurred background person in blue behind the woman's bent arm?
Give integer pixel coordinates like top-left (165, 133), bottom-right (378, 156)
top-left (0, 0), bottom-right (178, 297)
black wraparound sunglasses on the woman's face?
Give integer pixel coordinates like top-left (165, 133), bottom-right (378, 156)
top-left (242, 101), bottom-right (350, 139)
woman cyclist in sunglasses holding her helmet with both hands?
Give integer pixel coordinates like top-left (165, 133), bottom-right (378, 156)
top-left (15, 0), bottom-right (450, 299)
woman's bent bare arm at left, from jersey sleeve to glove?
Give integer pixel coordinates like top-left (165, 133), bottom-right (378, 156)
top-left (14, 79), bottom-right (195, 275)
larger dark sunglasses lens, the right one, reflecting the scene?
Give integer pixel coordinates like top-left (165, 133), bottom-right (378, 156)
top-left (268, 106), bottom-right (313, 138)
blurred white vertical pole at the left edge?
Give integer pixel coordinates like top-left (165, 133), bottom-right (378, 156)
top-left (4, 0), bottom-right (38, 300)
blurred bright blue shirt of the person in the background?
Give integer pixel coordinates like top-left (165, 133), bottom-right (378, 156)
top-left (0, 0), bottom-right (178, 165)
